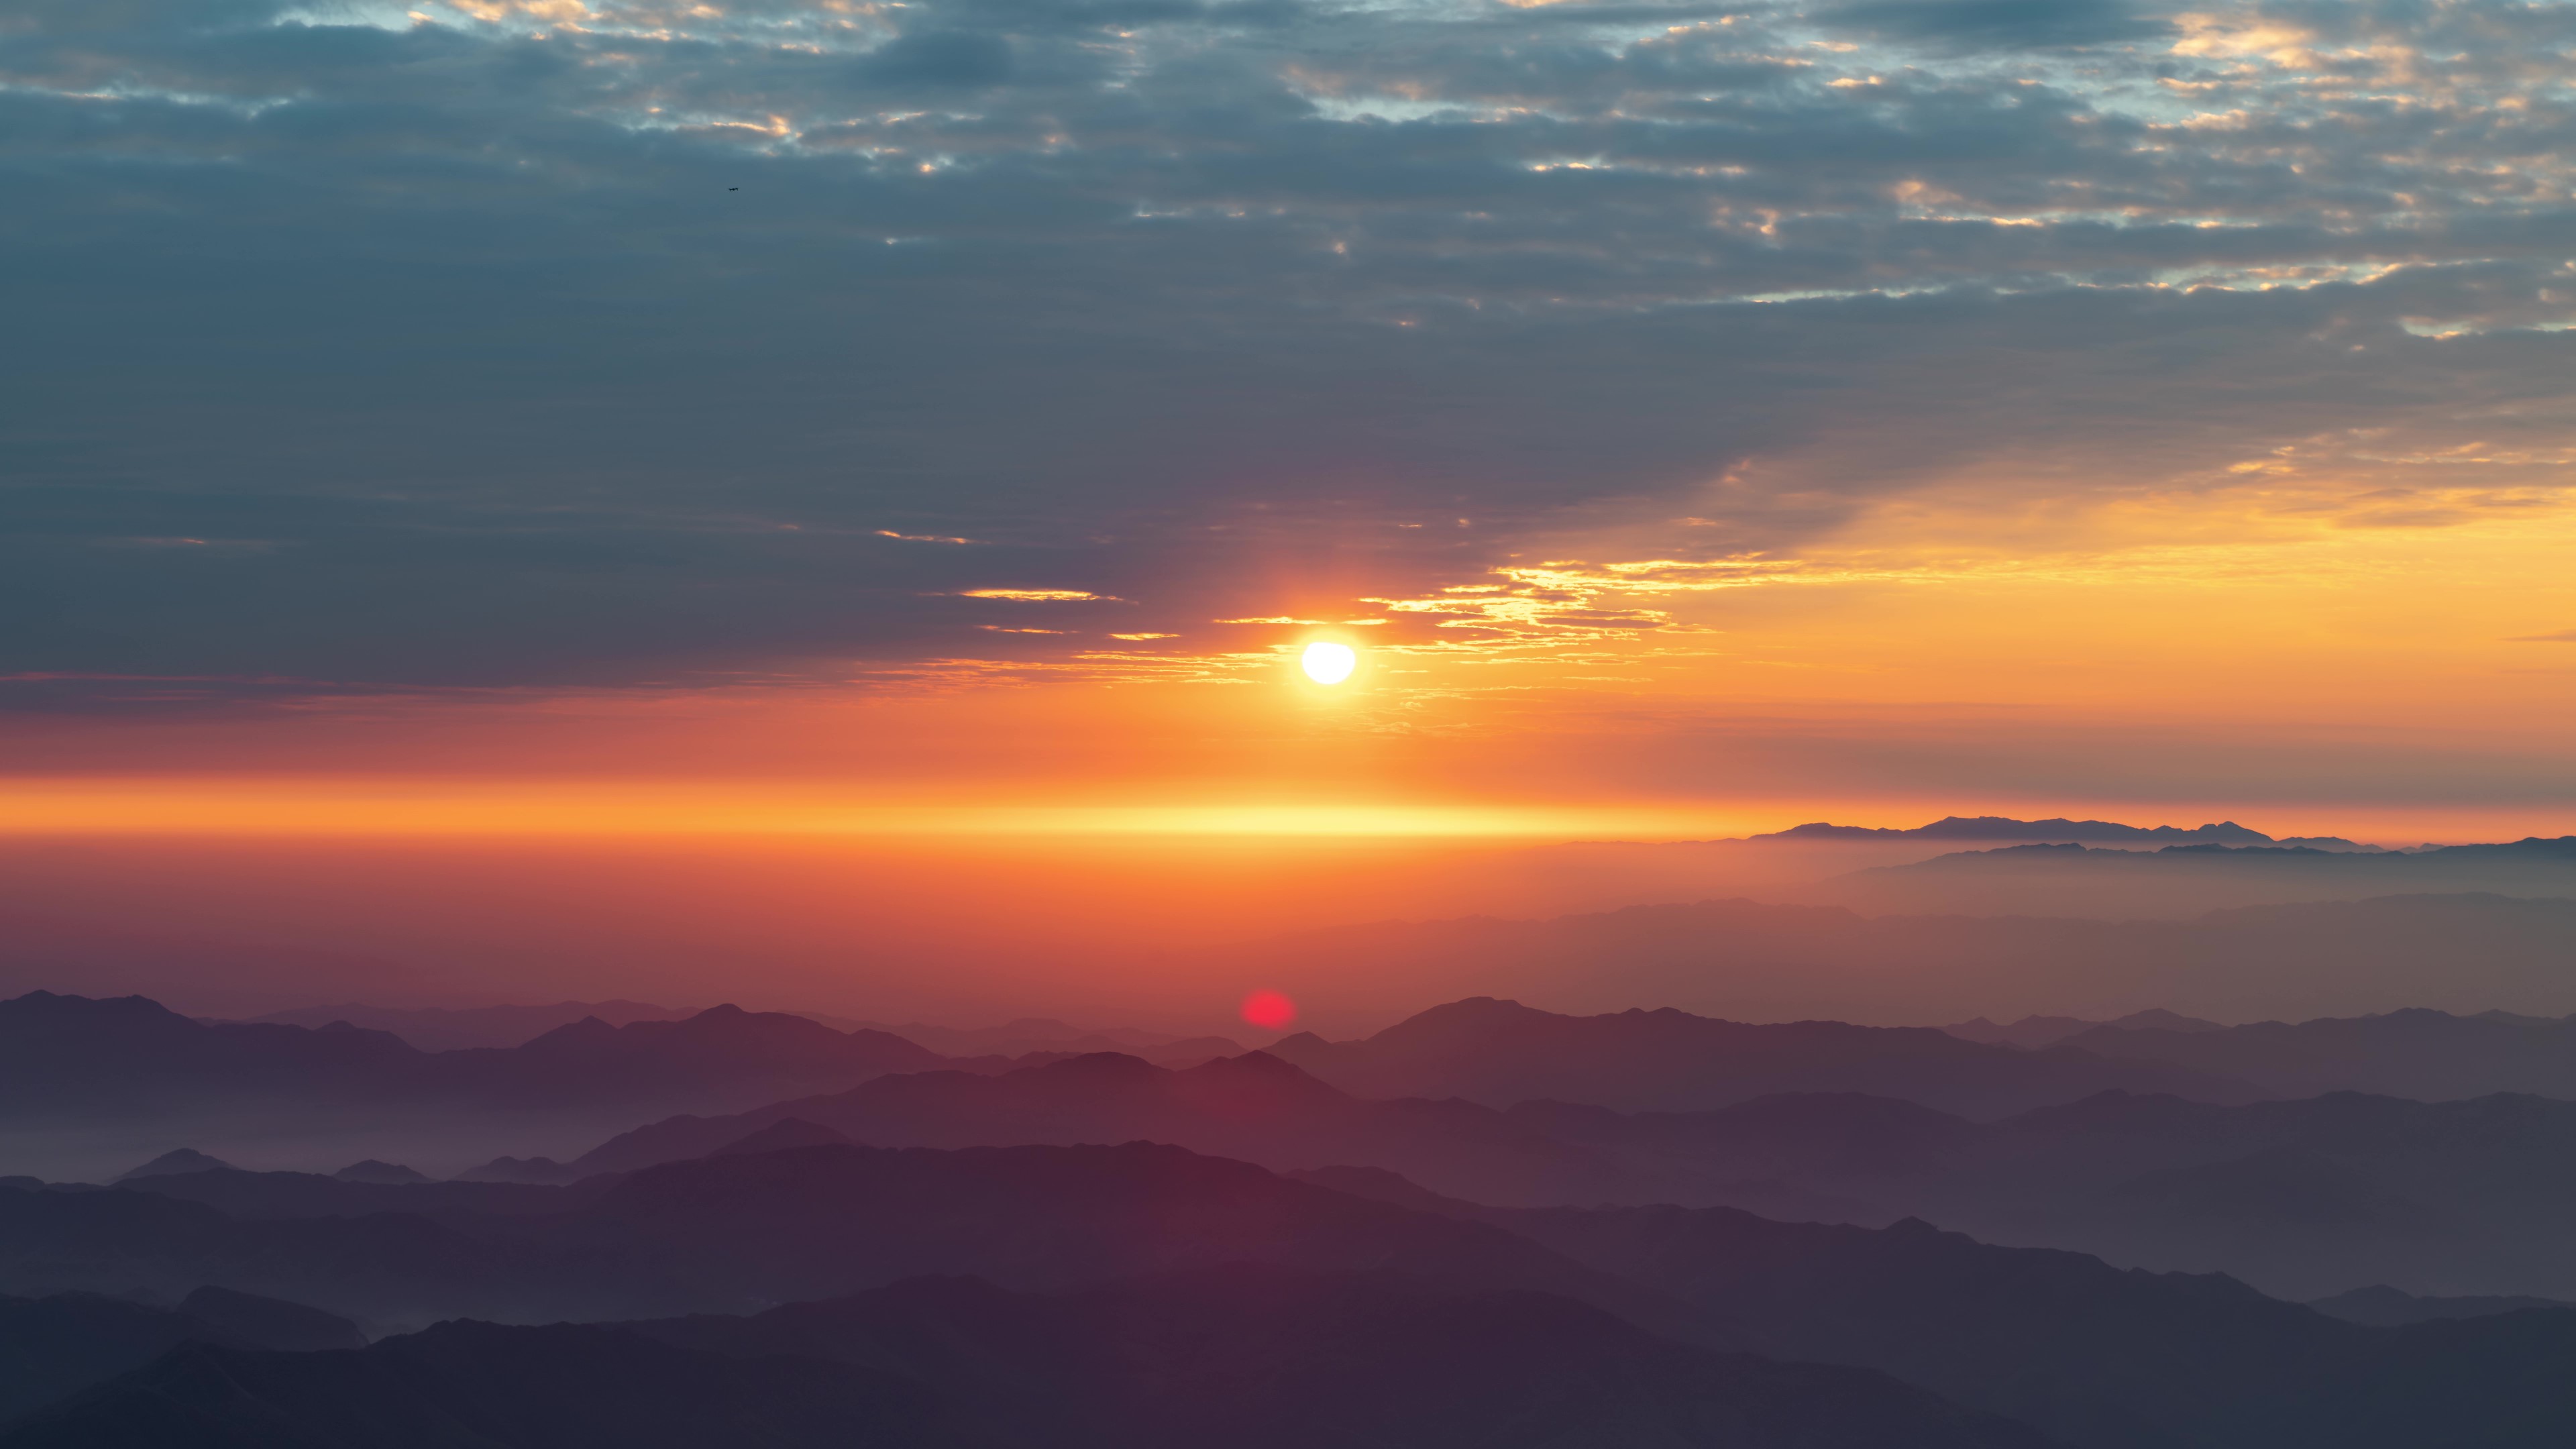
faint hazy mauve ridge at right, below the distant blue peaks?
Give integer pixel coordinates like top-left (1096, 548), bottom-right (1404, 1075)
top-left (1229, 887), bottom-right (2576, 1029)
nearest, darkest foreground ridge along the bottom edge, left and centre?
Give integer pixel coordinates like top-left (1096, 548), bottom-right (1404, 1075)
top-left (0, 1266), bottom-right (2045, 1449)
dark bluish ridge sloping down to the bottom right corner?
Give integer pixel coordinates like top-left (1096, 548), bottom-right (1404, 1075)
top-left (1313, 1173), bottom-right (2576, 1449)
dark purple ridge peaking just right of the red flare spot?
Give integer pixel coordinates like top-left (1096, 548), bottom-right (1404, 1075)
top-left (1270, 998), bottom-right (2262, 1116)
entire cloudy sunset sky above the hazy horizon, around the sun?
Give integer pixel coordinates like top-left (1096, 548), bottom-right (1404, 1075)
top-left (0, 0), bottom-right (2576, 848)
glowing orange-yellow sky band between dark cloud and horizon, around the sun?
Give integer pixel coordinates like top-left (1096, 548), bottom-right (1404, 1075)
top-left (0, 469), bottom-right (2576, 843)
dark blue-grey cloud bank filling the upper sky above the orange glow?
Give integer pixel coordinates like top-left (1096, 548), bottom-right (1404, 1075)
top-left (0, 0), bottom-right (2576, 706)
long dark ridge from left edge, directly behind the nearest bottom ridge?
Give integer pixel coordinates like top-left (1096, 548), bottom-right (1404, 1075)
top-left (0, 1142), bottom-right (1695, 1336)
